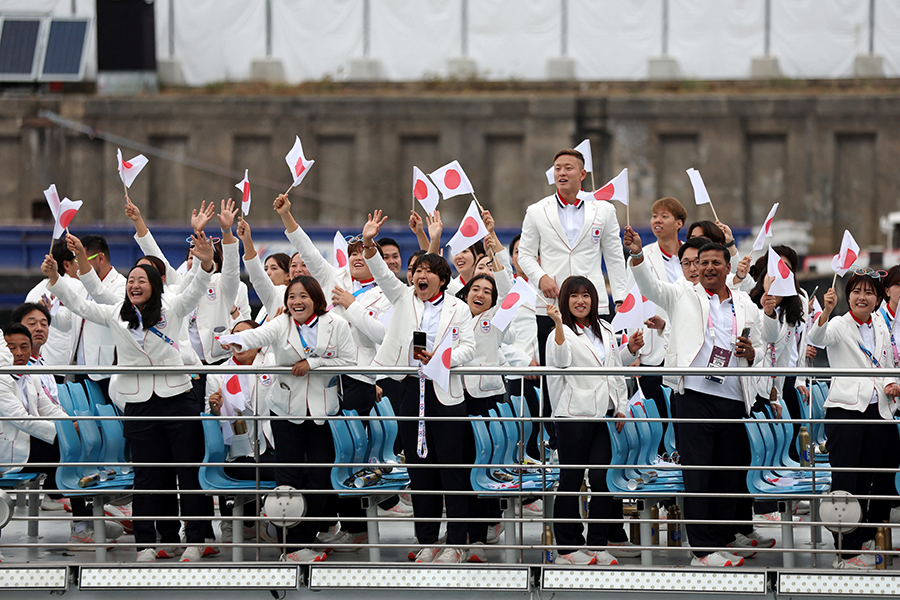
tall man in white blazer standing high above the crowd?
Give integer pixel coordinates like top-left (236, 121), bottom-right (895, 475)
top-left (519, 149), bottom-right (628, 364)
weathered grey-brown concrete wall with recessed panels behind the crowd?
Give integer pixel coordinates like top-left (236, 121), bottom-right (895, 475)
top-left (0, 92), bottom-right (900, 253)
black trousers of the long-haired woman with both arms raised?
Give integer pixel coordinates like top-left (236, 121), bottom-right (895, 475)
top-left (124, 392), bottom-right (213, 551)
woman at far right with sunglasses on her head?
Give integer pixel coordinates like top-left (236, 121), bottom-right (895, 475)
top-left (809, 268), bottom-right (900, 569)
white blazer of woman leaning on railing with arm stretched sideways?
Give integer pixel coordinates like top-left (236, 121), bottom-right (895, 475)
top-left (235, 313), bottom-right (356, 425)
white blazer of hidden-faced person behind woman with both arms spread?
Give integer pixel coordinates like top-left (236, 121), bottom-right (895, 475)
top-left (134, 232), bottom-right (243, 363)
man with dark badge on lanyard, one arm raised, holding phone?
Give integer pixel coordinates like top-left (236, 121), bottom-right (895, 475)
top-left (624, 227), bottom-right (762, 567)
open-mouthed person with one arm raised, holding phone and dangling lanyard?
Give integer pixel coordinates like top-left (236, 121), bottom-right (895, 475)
top-left (363, 210), bottom-right (475, 562)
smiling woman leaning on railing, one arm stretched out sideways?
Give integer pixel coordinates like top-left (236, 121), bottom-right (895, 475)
top-left (221, 275), bottom-right (356, 562)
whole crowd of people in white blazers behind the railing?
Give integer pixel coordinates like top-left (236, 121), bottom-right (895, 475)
top-left (0, 149), bottom-right (900, 569)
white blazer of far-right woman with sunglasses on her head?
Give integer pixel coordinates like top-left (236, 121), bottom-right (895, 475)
top-left (809, 312), bottom-right (900, 419)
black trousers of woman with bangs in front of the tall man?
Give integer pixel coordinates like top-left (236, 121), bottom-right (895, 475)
top-left (553, 419), bottom-right (628, 554)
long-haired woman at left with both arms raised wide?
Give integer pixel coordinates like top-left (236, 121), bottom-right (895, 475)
top-left (41, 232), bottom-right (214, 562)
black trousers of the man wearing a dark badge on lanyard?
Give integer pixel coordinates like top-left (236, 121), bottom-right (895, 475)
top-left (676, 390), bottom-right (747, 556)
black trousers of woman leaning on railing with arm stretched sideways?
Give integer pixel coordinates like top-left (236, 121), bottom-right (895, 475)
top-left (272, 415), bottom-right (334, 552)
